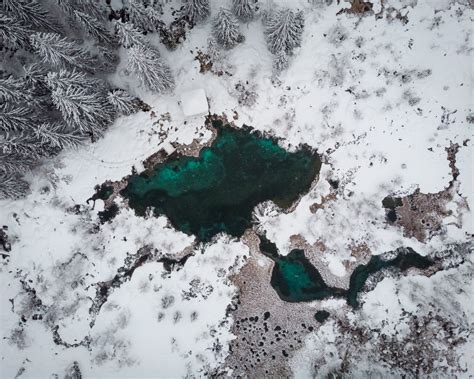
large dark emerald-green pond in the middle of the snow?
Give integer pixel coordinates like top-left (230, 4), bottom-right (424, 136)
top-left (121, 121), bottom-right (321, 241)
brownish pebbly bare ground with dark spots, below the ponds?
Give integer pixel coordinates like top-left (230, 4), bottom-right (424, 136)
top-left (221, 231), bottom-right (336, 378)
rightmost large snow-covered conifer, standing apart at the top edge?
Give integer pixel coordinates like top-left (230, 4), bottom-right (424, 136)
top-left (266, 9), bottom-right (304, 54)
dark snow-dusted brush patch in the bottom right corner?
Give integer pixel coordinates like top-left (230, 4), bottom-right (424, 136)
top-left (322, 309), bottom-right (470, 378)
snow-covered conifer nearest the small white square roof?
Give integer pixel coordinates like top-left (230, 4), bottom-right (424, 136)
top-left (127, 46), bottom-right (174, 92)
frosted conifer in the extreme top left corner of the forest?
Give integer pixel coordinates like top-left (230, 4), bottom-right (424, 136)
top-left (2, 0), bottom-right (60, 32)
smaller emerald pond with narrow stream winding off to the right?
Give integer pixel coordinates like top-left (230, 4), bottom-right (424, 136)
top-left (260, 236), bottom-right (434, 308)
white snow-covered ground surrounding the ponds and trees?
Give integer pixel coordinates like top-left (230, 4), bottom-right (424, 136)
top-left (0, 0), bottom-right (474, 378)
